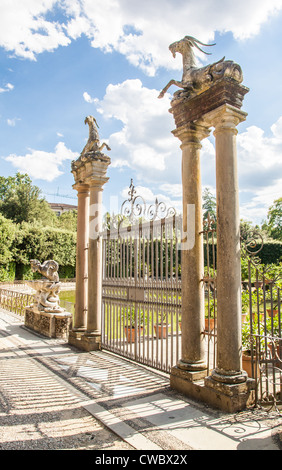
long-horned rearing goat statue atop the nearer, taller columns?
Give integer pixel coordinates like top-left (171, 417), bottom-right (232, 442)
top-left (159, 36), bottom-right (243, 98)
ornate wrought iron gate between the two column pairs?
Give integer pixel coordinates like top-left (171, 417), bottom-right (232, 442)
top-left (102, 182), bottom-right (181, 372)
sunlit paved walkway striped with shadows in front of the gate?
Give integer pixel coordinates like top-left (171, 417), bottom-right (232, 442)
top-left (0, 310), bottom-right (282, 451)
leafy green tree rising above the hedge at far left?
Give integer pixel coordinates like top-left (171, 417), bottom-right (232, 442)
top-left (0, 172), bottom-right (56, 225)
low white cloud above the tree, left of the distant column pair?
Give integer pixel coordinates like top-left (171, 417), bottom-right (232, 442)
top-left (5, 142), bottom-right (78, 181)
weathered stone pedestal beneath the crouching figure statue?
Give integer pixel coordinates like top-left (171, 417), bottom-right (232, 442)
top-left (24, 307), bottom-right (72, 339)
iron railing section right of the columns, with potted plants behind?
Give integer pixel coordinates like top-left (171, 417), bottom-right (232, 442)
top-left (241, 231), bottom-right (282, 407)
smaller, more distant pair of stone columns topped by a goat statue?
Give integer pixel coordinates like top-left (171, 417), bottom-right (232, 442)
top-left (69, 116), bottom-right (111, 351)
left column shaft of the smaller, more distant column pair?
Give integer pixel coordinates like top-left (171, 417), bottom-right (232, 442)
top-left (73, 183), bottom-right (89, 331)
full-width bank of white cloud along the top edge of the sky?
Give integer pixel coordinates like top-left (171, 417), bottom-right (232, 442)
top-left (0, 0), bottom-right (282, 75)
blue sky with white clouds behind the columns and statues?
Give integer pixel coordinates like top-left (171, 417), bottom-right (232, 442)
top-left (0, 0), bottom-right (282, 223)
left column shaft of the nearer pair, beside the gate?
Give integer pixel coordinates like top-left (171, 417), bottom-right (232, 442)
top-left (173, 123), bottom-right (209, 372)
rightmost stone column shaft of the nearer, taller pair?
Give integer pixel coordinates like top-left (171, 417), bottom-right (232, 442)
top-left (205, 105), bottom-right (249, 384)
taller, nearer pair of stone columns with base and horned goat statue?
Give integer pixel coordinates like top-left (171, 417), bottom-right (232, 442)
top-left (166, 36), bottom-right (250, 411)
